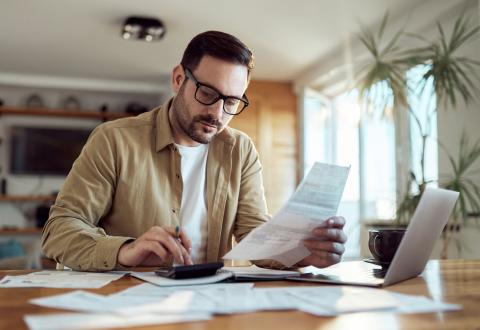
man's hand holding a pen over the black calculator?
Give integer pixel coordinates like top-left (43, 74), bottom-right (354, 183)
top-left (117, 226), bottom-right (193, 266)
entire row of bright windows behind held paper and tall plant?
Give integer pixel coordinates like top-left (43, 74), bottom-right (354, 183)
top-left (302, 66), bottom-right (438, 259)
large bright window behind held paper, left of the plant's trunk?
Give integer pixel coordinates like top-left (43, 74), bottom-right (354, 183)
top-left (303, 84), bottom-right (396, 259)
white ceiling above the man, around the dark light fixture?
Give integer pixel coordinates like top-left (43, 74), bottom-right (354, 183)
top-left (0, 0), bottom-right (466, 91)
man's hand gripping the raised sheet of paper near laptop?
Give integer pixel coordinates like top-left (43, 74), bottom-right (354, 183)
top-left (297, 217), bottom-right (347, 268)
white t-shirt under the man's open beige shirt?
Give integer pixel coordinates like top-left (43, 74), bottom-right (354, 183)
top-left (177, 144), bottom-right (208, 263)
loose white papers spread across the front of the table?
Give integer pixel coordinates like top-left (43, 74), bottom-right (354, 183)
top-left (25, 283), bottom-right (461, 330)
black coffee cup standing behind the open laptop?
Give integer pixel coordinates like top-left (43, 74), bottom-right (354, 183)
top-left (368, 228), bottom-right (406, 262)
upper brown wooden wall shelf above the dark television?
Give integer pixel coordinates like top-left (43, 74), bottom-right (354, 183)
top-left (0, 107), bottom-right (132, 120)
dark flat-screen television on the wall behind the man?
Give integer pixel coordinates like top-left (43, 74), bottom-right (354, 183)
top-left (10, 126), bottom-right (92, 176)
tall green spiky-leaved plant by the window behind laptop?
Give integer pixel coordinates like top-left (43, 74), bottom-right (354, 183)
top-left (357, 14), bottom-right (480, 257)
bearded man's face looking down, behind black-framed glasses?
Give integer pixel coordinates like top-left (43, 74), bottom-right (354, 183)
top-left (169, 56), bottom-right (248, 146)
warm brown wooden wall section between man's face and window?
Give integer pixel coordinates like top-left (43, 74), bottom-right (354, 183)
top-left (230, 81), bottom-right (299, 214)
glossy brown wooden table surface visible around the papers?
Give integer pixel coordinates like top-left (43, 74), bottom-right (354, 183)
top-left (0, 260), bottom-right (480, 330)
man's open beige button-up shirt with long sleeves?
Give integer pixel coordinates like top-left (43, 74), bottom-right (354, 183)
top-left (42, 101), bottom-right (269, 271)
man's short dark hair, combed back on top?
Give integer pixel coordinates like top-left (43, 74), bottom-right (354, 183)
top-left (181, 31), bottom-right (254, 73)
